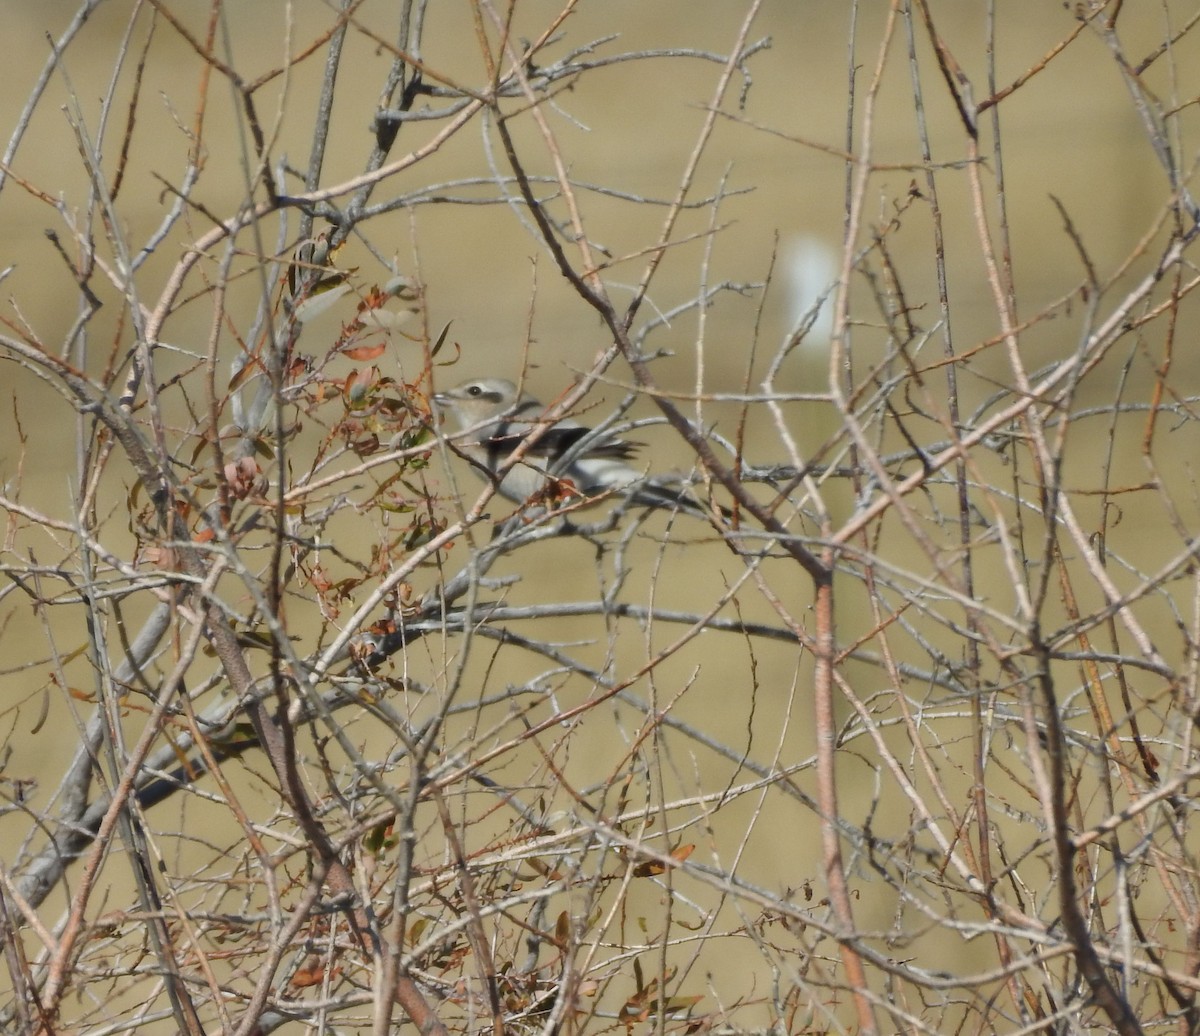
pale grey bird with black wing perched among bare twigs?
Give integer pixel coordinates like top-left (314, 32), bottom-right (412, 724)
top-left (433, 378), bottom-right (710, 519)
